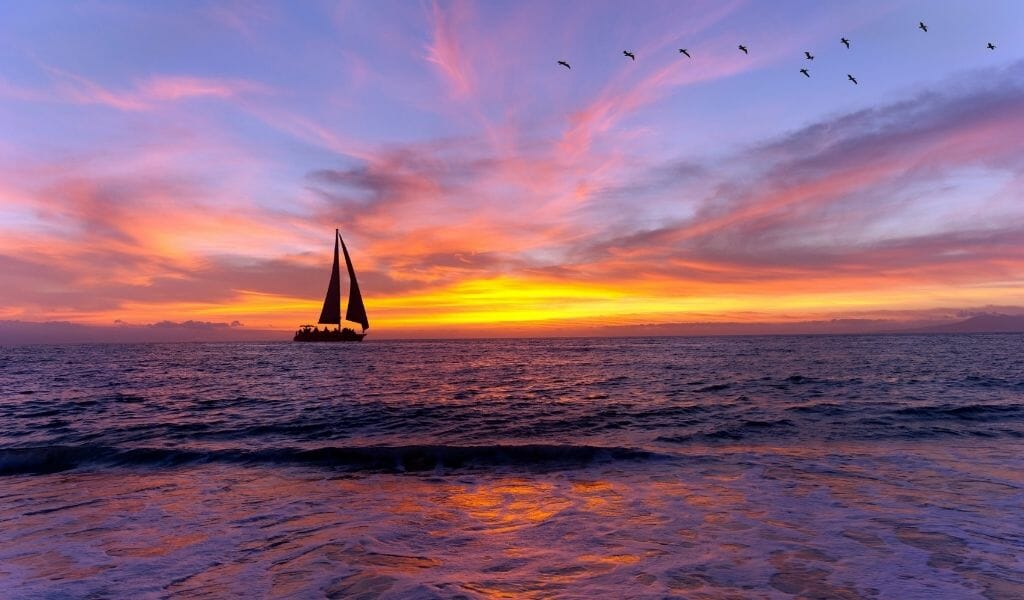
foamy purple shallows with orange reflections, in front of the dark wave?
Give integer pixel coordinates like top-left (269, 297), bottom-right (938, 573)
top-left (6, 434), bottom-right (1022, 598)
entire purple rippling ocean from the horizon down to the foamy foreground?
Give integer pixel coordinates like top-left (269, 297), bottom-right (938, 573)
top-left (0, 335), bottom-right (1024, 599)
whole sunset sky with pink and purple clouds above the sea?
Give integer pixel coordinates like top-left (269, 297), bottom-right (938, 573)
top-left (0, 0), bottom-right (1024, 337)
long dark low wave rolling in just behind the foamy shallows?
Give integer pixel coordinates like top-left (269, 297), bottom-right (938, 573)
top-left (0, 444), bottom-right (658, 475)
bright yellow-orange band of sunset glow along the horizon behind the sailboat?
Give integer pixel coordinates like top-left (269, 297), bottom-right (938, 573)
top-left (19, 276), bottom-right (1024, 333)
